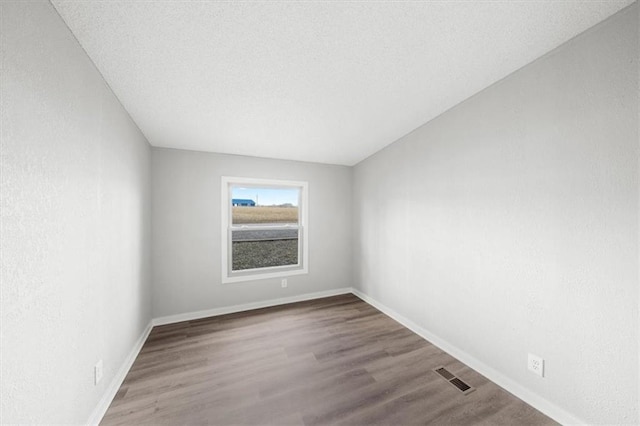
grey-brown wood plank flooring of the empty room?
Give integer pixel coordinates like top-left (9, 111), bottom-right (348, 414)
top-left (101, 295), bottom-right (556, 425)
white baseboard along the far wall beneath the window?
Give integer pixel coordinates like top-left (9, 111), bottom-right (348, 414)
top-left (153, 287), bottom-right (352, 326)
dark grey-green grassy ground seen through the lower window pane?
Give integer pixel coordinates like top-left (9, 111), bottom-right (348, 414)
top-left (232, 240), bottom-right (298, 271)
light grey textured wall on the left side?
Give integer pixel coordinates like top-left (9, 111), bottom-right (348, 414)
top-left (0, 1), bottom-right (151, 424)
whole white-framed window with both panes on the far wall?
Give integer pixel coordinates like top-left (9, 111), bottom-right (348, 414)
top-left (222, 176), bottom-right (308, 283)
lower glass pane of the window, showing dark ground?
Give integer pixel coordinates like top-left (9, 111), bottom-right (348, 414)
top-left (231, 229), bottom-right (298, 271)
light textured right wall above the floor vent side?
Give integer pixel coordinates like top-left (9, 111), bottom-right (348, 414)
top-left (353, 3), bottom-right (640, 424)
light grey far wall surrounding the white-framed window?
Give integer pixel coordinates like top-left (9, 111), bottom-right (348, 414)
top-left (151, 148), bottom-right (352, 317)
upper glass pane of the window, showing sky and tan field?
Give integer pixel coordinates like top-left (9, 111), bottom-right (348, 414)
top-left (231, 186), bottom-right (300, 225)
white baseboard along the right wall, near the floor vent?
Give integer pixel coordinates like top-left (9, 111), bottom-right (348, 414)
top-left (352, 288), bottom-right (586, 425)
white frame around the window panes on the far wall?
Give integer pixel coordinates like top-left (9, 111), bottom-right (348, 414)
top-left (220, 176), bottom-right (309, 283)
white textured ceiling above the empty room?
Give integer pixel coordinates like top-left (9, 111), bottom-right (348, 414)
top-left (52, 0), bottom-right (633, 165)
